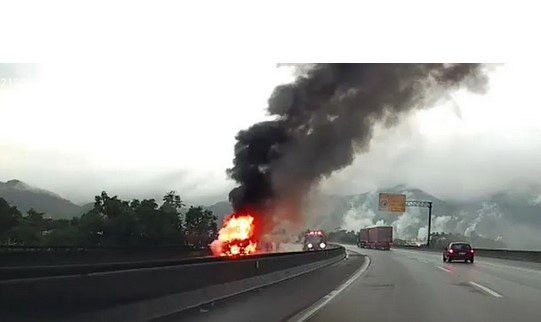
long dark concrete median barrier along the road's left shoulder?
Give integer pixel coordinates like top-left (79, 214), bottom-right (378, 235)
top-left (0, 247), bottom-right (345, 321)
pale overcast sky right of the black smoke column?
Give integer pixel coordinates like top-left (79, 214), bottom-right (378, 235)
top-left (320, 64), bottom-right (541, 199)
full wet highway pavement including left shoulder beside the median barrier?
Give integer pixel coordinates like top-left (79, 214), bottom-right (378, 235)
top-left (167, 246), bottom-right (541, 322)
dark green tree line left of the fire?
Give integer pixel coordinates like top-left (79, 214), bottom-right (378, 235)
top-left (0, 191), bottom-right (217, 248)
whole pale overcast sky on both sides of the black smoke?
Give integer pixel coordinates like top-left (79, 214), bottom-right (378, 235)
top-left (0, 62), bottom-right (541, 202)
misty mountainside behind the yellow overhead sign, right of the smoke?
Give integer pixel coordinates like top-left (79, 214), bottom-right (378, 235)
top-left (309, 185), bottom-right (541, 249)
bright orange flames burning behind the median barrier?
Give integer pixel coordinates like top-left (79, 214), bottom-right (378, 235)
top-left (210, 214), bottom-right (257, 256)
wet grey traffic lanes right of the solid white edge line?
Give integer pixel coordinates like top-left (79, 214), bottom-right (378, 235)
top-left (309, 246), bottom-right (541, 322)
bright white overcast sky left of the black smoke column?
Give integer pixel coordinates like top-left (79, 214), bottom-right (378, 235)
top-left (0, 62), bottom-right (293, 202)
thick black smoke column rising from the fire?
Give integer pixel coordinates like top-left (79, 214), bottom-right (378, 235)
top-left (227, 64), bottom-right (486, 230)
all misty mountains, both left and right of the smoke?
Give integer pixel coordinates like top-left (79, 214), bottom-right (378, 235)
top-left (0, 180), bottom-right (541, 249)
